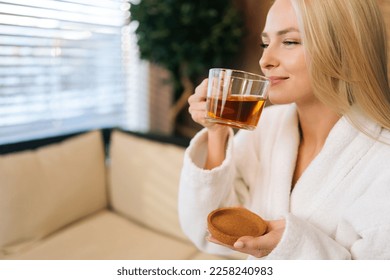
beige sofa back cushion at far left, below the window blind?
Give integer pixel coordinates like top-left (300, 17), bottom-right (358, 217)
top-left (0, 131), bottom-right (107, 258)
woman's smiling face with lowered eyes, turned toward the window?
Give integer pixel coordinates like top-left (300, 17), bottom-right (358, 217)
top-left (260, 0), bottom-right (314, 105)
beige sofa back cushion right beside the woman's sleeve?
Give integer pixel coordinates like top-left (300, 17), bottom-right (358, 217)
top-left (109, 131), bottom-right (187, 241)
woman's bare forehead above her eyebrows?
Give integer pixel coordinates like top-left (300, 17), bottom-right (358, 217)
top-left (264, 0), bottom-right (298, 33)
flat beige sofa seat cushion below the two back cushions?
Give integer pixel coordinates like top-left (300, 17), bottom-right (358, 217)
top-left (5, 210), bottom-right (201, 260)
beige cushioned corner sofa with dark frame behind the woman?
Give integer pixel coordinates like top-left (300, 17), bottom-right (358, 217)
top-left (0, 129), bottom-right (241, 260)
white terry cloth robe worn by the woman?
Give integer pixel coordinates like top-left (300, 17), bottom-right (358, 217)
top-left (179, 104), bottom-right (390, 259)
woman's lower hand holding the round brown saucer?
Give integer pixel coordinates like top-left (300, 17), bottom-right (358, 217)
top-left (207, 220), bottom-right (286, 258)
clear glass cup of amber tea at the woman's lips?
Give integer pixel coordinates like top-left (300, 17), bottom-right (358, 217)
top-left (206, 68), bottom-right (270, 130)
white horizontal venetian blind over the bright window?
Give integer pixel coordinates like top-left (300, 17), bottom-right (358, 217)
top-left (0, 0), bottom-right (146, 144)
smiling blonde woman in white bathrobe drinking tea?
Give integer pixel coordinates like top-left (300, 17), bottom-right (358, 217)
top-left (179, 0), bottom-right (390, 259)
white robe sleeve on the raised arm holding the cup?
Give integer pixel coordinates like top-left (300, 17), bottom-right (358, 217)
top-left (178, 130), bottom-right (248, 255)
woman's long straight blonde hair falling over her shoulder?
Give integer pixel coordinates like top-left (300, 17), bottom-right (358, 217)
top-left (291, 0), bottom-right (390, 137)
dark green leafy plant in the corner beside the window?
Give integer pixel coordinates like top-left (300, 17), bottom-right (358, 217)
top-left (130, 0), bottom-right (244, 120)
